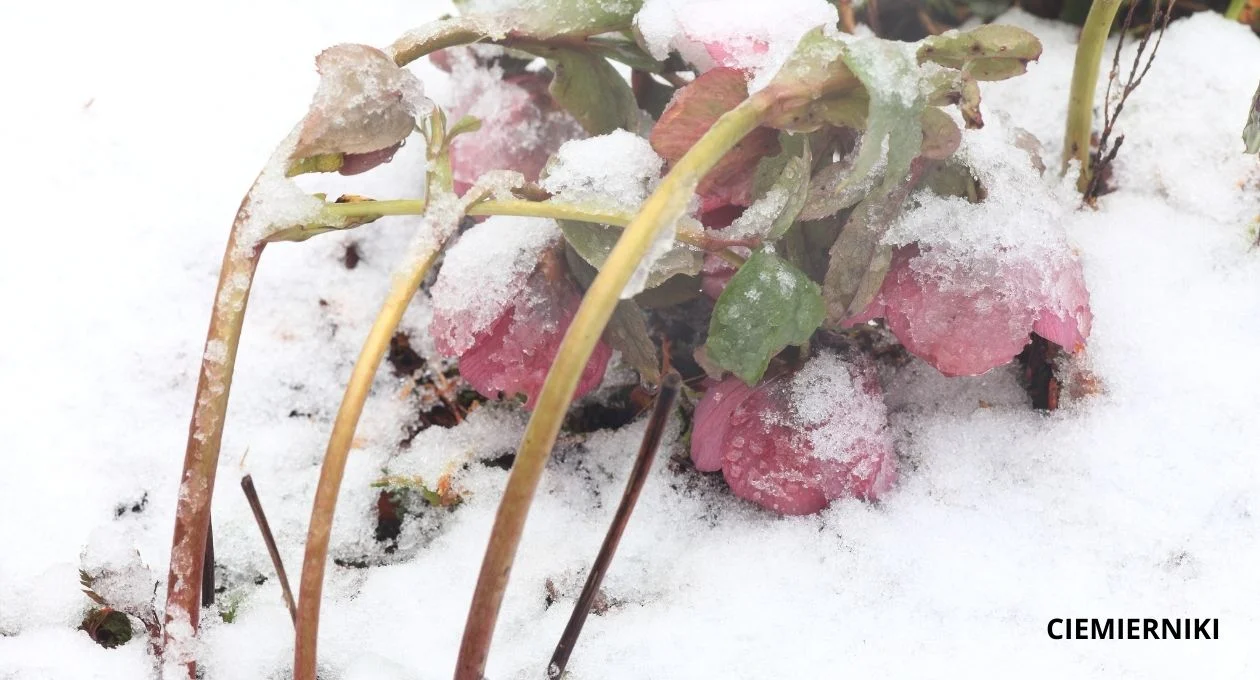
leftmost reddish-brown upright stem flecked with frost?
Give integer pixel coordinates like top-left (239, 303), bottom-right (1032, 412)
top-left (163, 219), bottom-right (263, 676)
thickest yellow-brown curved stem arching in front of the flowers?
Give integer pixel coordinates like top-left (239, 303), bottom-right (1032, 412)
top-left (455, 91), bottom-right (775, 680)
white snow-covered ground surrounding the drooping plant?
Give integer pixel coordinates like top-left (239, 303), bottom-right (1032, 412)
top-left (0, 0), bottom-right (1260, 680)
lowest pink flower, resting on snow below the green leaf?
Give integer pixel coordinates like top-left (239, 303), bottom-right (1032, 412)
top-left (692, 354), bottom-right (897, 515)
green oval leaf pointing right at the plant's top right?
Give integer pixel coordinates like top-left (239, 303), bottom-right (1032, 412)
top-left (919, 24), bottom-right (1041, 81)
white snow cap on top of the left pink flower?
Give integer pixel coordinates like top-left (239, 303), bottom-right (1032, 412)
top-left (430, 217), bottom-right (561, 356)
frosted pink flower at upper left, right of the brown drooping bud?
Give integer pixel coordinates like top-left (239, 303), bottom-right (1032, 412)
top-left (447, 50), bottom-right (586, 194)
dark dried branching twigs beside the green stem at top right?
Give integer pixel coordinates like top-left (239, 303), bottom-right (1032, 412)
top-left (1085, 0), bottom-right (1177, 205)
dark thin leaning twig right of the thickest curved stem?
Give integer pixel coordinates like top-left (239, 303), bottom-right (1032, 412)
top-left (547, 365), bottom-right (683, 680)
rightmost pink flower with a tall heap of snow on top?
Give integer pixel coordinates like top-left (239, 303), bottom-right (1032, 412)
top-left (845, 117), bottom-right (1091, 375)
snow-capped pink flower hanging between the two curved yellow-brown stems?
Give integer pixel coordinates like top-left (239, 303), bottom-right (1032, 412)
top-left (430, 217), bottom-right (612, 409)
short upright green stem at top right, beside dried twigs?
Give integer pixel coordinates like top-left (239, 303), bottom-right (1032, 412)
top-left (1062, 0), bottom-right (1120, 191)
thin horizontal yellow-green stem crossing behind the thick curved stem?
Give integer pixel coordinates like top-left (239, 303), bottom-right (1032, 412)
top-left (324, 200), bottom-right (745, 267)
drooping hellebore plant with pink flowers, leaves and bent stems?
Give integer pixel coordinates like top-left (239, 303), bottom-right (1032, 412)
top-left (157, 0), bottom-right (1090, 680)
